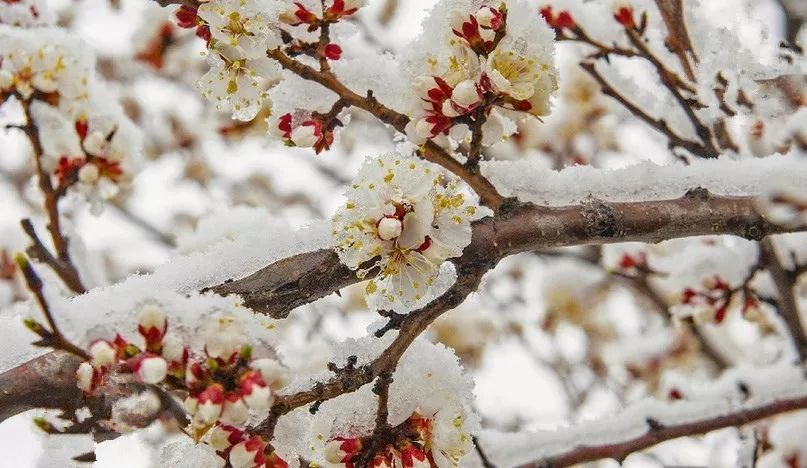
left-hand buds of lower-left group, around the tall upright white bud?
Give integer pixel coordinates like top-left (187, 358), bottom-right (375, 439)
top-left (76, 305), bottom-right (177, 394)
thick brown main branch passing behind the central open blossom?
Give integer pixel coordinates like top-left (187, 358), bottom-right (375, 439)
top-left (211, 191), bottom-right (805, 318)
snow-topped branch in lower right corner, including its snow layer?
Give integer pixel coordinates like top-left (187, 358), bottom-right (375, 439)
top-left (480, 364), bottom-right (807, 468)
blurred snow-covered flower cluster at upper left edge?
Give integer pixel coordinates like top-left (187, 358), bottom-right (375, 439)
top-left (0, 27), bottom-right (140, 208)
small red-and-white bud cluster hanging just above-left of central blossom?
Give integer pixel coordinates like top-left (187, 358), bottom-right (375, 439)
top-left (270, 111), bottom-right (339, 154)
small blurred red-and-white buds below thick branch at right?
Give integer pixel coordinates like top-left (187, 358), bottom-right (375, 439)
top-left (681, 275), bottom-right (761, 324)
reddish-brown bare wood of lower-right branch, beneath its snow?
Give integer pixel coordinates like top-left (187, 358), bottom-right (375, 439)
top-left (521, 396), bottom-right (807, 468)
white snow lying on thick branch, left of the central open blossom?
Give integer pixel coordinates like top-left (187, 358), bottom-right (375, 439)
top-left (0, 208), bottom-right (330, 371)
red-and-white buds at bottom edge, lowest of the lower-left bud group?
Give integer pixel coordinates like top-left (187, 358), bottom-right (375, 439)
top-left (206, 424), bottom-right (289, 468)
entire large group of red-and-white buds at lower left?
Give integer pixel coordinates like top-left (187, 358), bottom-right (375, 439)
top-left (76, 305), bottom-right (288, 468)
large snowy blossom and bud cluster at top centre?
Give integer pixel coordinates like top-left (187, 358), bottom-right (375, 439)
top-left (409, 3), bottom-right (557, 142)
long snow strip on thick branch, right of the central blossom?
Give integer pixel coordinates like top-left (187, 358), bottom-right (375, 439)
top-left (482, 155), bottom-right (807, 206)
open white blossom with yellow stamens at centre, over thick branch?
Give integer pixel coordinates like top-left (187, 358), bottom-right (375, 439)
top-left (333, 153), bottom-right (478, 309)
